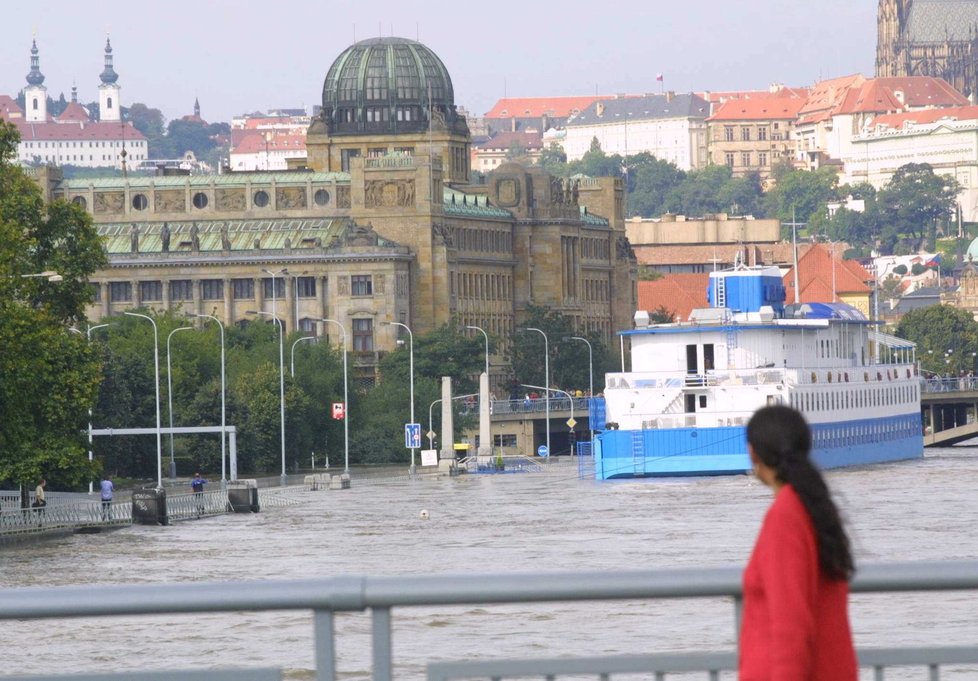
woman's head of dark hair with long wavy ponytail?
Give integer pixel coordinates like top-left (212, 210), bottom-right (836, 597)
top-left (747, 406), bottom-right (856, 579)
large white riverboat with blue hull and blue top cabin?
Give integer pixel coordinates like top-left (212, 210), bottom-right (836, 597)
top-left (592, 267), bottom-right (923, 480)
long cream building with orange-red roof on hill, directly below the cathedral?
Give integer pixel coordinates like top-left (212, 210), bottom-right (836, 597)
top-left (794, 74), bottom-right (970, 170)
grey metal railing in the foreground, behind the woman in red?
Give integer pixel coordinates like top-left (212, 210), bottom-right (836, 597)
top-left (0, 561), bottom-right (978, 681)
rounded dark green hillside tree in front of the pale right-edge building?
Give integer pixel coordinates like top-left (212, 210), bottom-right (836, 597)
top-left (877, 163), bottom-right (961, 253)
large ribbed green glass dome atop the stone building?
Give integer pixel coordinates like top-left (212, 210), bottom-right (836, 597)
top-left (321, 38), bottom-right (465, 135)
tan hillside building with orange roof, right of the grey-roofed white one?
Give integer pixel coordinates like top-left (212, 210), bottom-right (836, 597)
top-left (707, 89), bottom-right (806, 186)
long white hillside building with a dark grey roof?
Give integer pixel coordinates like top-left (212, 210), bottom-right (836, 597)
top-left (556, 92), bottom-right (710, 170)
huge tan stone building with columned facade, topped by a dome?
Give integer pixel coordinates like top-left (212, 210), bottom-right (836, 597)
top-left (49, 38), bottom-right (636, 385)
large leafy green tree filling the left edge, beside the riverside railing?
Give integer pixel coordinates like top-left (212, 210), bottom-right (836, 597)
top-left (0, 121), bottom-right (105, 499)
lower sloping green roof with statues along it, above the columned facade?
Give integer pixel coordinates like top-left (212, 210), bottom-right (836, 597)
top-left (97, 218), bottom-right (370, 255)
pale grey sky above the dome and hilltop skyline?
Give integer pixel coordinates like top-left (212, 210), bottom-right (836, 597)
top-left (0, 0), bottom-right (877, 121)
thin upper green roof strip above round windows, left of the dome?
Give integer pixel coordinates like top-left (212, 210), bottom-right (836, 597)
top-left (58, 172), bottom-right (350, 191)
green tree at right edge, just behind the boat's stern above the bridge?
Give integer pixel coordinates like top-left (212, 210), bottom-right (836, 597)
top-left (896, 305), bottom-right (978, 375)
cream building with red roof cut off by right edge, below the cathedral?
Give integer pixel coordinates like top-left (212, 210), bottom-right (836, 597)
top-left (842, 106), bottom-right (978, 222)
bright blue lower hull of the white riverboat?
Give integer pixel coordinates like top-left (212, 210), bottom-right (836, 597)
top-left (594, 414), bottom-right (924, 480)
